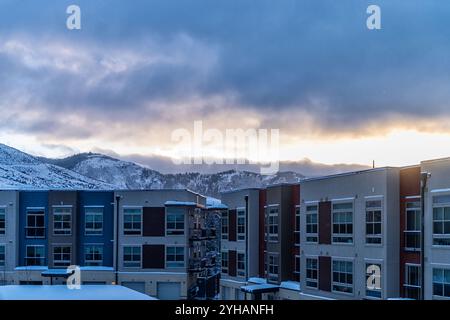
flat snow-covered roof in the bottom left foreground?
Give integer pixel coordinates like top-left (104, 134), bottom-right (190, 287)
top-left (0, 285), bottom-right (157, 300)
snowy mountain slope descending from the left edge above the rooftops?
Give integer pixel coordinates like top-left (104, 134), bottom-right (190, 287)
top-left (0, 144), bottom-right (113, 189)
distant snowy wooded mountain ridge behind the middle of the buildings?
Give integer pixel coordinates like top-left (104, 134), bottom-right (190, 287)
top-left (41, 153), bottom-right (303, 197)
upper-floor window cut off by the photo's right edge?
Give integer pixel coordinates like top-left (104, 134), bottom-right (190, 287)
top-left (433, 196), bottom-right (450, 246)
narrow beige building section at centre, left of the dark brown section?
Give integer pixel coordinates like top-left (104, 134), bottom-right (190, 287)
top-left (220, 188), bottom-right (265, 300)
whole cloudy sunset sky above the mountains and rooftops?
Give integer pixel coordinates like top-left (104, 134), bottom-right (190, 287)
top-left (0, 0), bottom-right (450, 169)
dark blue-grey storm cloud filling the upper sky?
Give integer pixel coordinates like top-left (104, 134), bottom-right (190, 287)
top-left (0, 0), bottom-right (450, 136)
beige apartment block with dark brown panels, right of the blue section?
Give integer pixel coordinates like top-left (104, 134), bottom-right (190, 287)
top-left (115, 190), bottom-right (219, 300)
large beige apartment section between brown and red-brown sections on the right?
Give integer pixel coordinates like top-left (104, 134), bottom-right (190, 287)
top-left (300, 168), bottom-right (400, 299)
